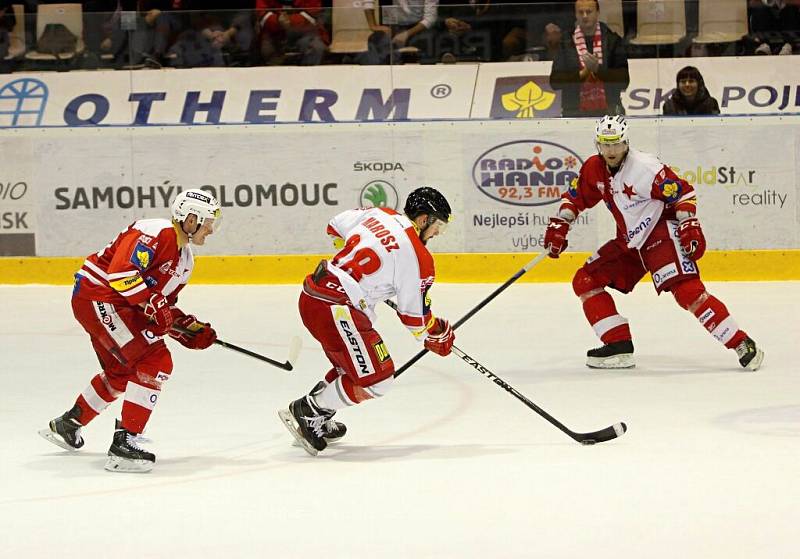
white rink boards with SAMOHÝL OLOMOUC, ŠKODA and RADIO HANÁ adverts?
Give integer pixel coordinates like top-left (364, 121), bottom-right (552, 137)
top-left (0, 117), bottom-right (800, 256)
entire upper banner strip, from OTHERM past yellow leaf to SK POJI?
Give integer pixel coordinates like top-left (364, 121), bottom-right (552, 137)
top-left (0, 56), bottom-right (800, 128)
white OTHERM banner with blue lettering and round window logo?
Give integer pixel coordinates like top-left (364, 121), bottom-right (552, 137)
top-left (0, 65), bottom-right (478, 127)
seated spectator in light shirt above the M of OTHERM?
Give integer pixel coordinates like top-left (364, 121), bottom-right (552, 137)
top-left (362, 0), bottom-right (439, 64)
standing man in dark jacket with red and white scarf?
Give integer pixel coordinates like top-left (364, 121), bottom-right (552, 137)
top-left (550, 0), bottom-right (630, 117)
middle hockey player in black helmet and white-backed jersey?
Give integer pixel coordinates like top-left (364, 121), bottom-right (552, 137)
top-left (278, 187), bottom-right (455, 455)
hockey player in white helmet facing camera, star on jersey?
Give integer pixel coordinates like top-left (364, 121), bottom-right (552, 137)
top-left (544, 116), bottom-right (764, 371)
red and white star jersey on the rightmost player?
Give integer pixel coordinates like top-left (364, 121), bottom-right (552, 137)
top-left (561, 149), bottom-right (697, 249)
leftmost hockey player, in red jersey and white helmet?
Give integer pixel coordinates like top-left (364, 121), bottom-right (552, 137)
top-left (39, 189), bottom-right (220, 472)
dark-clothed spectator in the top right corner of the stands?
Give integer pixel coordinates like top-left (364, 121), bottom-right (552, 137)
top-left (748, 0), bottom-right (800, 54)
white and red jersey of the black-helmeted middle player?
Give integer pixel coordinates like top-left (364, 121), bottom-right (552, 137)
top-left (328, 208), bottom-right (435, 339)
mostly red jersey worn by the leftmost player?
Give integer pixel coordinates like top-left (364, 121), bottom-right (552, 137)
top-left (75, 219), bottom-right (194, 305)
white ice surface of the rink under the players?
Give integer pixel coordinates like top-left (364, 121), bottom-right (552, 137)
top-left (0, 283), bottom-right (800, 559)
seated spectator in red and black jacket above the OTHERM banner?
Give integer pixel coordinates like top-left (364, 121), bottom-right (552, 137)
top-left (256, 0), bottom-right (330, 66)
